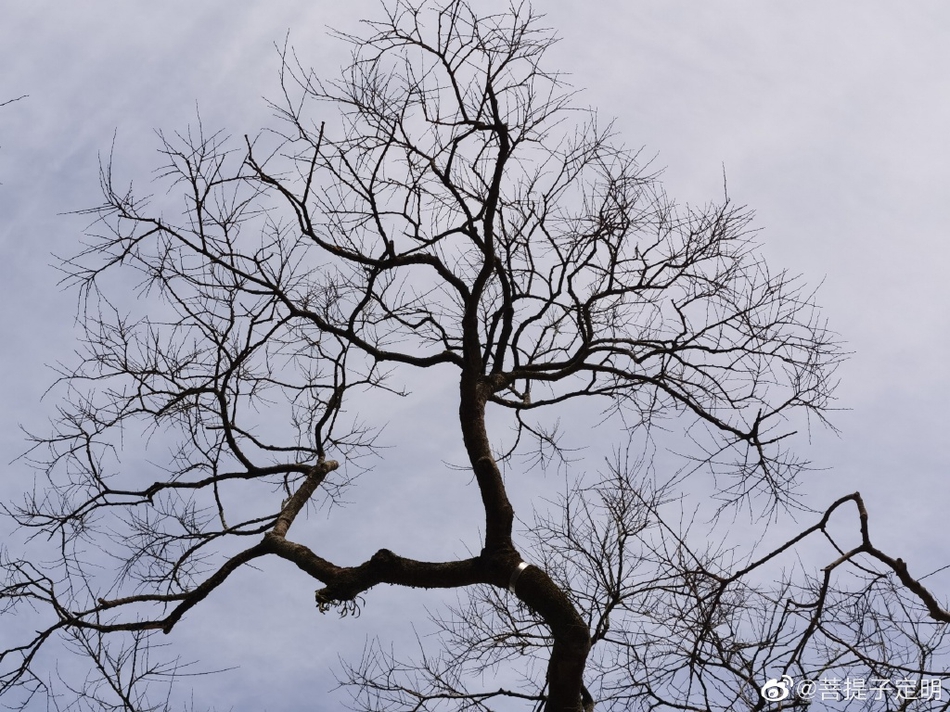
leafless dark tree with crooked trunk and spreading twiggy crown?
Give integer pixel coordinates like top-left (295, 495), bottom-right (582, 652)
top-left (0, 0), bottom-right (950, 712)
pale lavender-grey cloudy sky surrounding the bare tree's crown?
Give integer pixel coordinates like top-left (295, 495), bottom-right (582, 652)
top-left (0, 0), bottom-right (950, 711)
